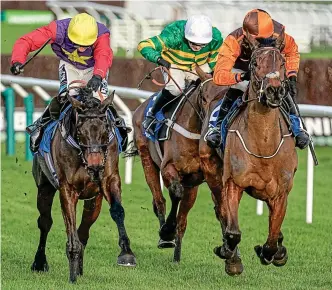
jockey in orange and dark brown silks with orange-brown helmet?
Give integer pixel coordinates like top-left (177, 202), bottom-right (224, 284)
top-left (206, 9), bottom-right (310, 149)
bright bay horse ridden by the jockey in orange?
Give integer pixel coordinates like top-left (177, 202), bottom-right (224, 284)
top-left (200, 40), bottom-right (298, 275)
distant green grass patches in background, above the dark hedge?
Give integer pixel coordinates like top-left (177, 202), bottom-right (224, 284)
top-left (1, 23), bottom-right (332, 58)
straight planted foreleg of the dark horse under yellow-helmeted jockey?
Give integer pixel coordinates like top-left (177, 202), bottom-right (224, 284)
top-left (60, 185), bottom-right (83, 283)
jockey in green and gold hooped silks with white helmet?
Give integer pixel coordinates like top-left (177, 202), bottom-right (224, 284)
top-left (137, 15), bottom-right (223, 135)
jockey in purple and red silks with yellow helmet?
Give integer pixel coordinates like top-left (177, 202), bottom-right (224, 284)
top-left (10, 13), bottom-right (126, 152)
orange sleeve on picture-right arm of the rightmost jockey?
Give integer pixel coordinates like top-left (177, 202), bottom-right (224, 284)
top-left (282, 33), bottom-right (300, 77)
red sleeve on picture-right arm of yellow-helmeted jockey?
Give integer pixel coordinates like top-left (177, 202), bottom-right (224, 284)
top-left (93, 33), bottom-right (113, 78)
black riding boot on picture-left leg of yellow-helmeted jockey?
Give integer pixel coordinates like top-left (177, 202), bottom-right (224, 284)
top-left (25, 97), bottom-right (61, 152)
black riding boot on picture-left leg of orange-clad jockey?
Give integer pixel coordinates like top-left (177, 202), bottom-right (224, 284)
top-left (205, 88), bottom-right (243, 148)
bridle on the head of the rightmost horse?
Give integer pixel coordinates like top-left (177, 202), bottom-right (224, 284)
top-left (248, 47), bottom-right (287, 107)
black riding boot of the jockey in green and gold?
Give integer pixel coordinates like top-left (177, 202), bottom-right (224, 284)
top-left (142, 89), bottom-right (176, 135)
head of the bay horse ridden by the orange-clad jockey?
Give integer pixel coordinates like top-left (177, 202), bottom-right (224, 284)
top-left (246, 33), bottom-right (286, 108)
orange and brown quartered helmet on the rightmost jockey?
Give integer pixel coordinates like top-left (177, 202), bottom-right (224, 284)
top-left (242, 9), bottom-right (274, 38)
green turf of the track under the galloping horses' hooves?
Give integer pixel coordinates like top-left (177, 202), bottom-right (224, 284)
top-left (1, 144), bottom-right (332, 290)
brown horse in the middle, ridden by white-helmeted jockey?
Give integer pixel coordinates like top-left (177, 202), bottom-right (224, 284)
top-left (133, 66), bottom-right (226, 262)
